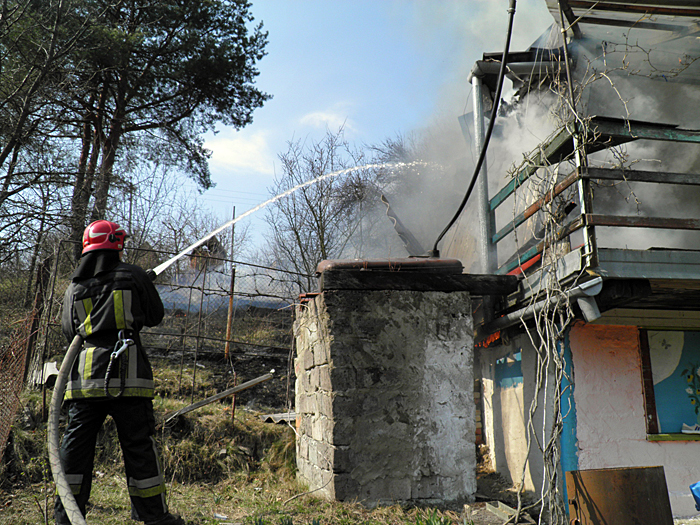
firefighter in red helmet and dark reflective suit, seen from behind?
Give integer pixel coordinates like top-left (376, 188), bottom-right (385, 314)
top-left (54, 220), bottom-right (185, 525)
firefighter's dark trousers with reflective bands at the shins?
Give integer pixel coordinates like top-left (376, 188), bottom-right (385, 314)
top-left (54, 397), bottom-right (168, 525)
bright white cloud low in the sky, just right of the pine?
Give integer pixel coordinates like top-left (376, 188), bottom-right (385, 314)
top-left (204, 131), bottom-right (276, 174)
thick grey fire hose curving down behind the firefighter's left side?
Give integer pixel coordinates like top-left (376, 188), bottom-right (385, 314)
top-left (48, 335), bottom-right (87, 525)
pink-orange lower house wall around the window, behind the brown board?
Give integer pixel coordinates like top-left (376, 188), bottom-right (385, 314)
top-left (569, 323), bottom-right (700, 516)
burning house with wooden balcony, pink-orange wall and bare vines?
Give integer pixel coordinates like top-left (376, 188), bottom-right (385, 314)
top-left (447, 0), bottom-right (700, 518)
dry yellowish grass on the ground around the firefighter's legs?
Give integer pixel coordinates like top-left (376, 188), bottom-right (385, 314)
top-left (0, 367), bottom-right (462, 525)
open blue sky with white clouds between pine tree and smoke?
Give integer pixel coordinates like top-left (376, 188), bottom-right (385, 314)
top-left (191, 0), bottom-right (553, 244)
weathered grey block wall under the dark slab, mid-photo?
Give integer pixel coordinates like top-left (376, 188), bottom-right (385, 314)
top-left (294, 284), bottom-right (476, 506)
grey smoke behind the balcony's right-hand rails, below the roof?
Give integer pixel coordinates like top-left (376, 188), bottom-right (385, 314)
top-left (574, 26), bottom-right (700, 250)
